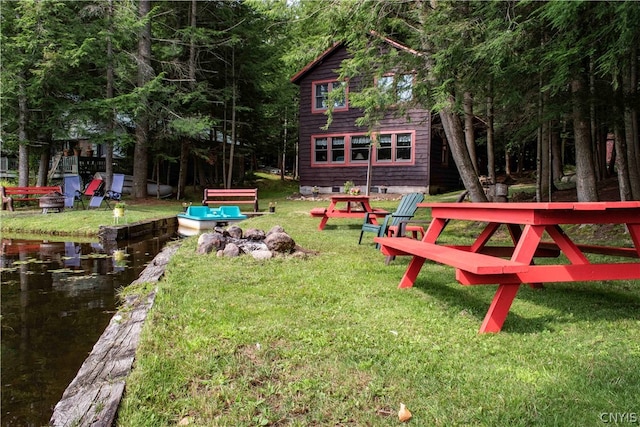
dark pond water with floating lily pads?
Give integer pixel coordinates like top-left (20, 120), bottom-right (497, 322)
top-left (0, 234), bottom-right (174, 427)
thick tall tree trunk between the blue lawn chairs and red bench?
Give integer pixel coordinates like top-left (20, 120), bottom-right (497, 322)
top-left (131, 0), bottom-right (152, 199)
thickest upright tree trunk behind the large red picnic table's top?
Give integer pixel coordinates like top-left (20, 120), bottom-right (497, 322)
top-left (571, 77), bottom-right (598, 202)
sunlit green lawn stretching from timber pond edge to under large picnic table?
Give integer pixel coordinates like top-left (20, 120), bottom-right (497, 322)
top-left (2, 176), bottom-right (640, 427)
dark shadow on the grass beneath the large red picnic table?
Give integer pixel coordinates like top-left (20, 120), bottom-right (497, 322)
top-left (404, 264), bottom-right (640, 334)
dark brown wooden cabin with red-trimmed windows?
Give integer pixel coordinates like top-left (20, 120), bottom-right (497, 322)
top-left (291, 40), bottom-right (462, 194)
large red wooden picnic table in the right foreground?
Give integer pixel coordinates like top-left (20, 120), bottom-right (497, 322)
top-left (375, 202), bottom-right (640, 333)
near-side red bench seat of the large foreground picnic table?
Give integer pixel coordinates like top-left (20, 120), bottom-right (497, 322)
top-left (374, 237), bottom-right (529, 274)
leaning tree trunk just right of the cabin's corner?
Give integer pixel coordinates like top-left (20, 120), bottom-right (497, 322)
top-left (440, 95), bottom-right (487, 202)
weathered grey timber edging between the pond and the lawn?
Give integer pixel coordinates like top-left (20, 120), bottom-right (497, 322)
top-left (49, 242), bottom-right (180, 427)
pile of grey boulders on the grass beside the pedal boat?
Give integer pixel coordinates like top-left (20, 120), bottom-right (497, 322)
top-left (196, 225), bottom-right (310, 259)
